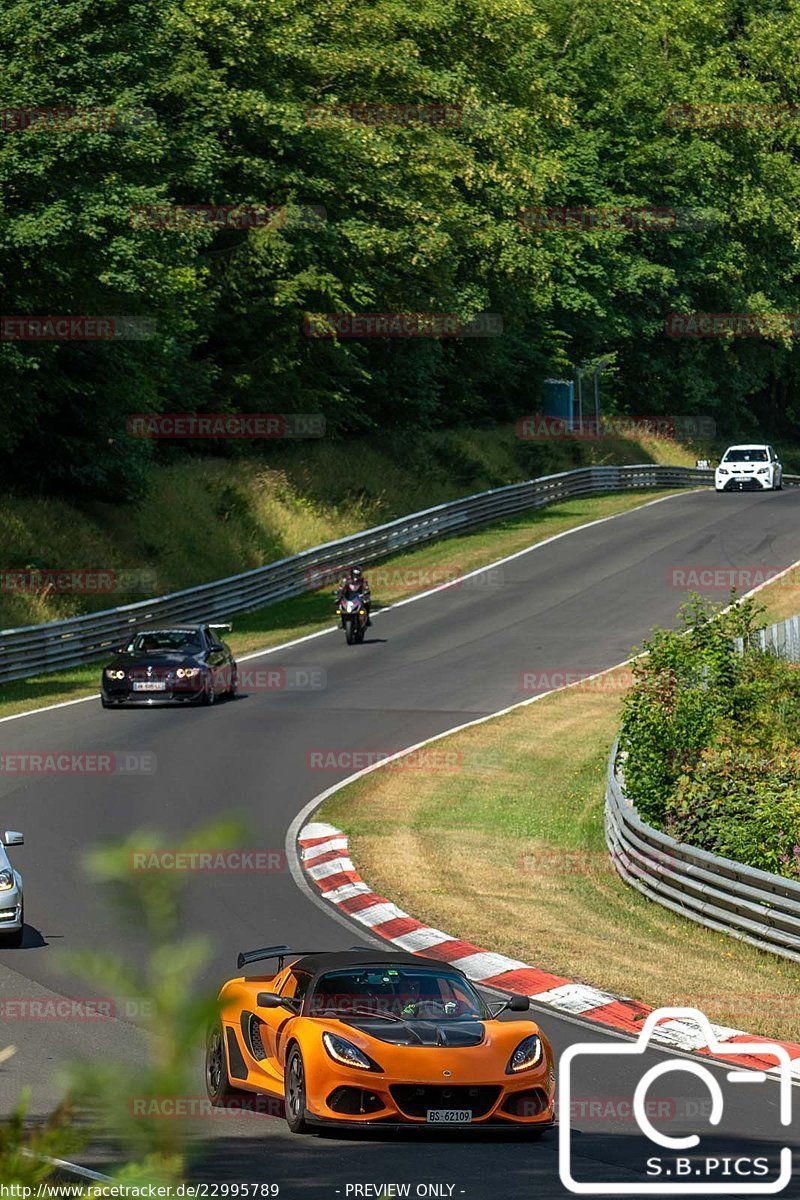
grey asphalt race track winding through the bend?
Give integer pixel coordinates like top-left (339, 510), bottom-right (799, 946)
top-left (0, 490), bottom-right (800, 1200)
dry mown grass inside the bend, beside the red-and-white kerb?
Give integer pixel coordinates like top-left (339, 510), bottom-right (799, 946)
top-left (317, 628), bottom-right (800, 1042)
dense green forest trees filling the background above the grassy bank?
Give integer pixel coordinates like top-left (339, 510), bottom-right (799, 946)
top-left (0, 0), bottom-right (800, 498)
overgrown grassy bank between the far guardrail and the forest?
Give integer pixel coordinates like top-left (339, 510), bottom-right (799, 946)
top-left (0, 426), bottom-right (699, 629)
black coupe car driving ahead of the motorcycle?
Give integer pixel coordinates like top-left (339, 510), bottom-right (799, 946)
top-left (101, 624), bottom-right (237, 708)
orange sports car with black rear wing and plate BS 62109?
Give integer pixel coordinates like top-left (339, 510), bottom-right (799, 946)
top-left (205, 946), bottom-right (555, 1134)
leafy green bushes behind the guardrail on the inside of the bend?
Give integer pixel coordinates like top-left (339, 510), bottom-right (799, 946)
top-left (620, 600), bottom-right (800, 878)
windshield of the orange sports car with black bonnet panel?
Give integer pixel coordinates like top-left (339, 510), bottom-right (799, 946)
top-left (307, 966), bottom-right (491, 1021)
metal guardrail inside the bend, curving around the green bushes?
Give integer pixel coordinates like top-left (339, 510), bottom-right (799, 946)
top-left (606, 617), bottom-right (800, 962)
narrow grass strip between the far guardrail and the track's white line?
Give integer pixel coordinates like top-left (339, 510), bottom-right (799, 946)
top-left (0, 488), bottom-right (682, 718)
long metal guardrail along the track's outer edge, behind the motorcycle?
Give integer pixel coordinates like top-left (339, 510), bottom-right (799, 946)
top-left (0, 464), bottom-right (714, 682)
